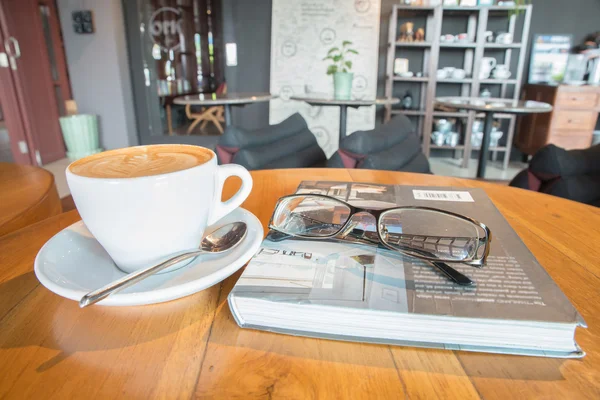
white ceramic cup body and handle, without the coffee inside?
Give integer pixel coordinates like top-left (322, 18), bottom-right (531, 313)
top-left (66, 145), bottom-right (252, 272)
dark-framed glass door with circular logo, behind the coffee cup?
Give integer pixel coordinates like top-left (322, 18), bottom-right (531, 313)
top-left (124, 0), bottom-right (224, 145)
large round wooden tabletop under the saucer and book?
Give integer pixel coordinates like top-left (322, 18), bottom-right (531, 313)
top-left (0, 169), bottom-right (600, 399)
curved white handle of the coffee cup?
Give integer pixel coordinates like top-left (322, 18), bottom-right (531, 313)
top-left (208, 164), bottom-right (252, 225)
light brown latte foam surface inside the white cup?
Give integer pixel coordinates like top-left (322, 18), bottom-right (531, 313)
top-left (69, 144), bottom-right (213, 178)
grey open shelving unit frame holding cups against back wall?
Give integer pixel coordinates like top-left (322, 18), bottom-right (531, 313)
top-left (385, 5), bottom-right (532, 169)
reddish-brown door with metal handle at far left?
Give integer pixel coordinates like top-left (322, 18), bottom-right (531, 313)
top-left (0, 0), bottom-right (71, 165)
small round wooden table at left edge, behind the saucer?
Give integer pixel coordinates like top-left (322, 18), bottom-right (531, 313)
top-left (0, 163), bottom-right (62, 236)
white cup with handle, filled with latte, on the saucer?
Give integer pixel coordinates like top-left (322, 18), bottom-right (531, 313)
top-left (65, 144), bottom-right (253, 273)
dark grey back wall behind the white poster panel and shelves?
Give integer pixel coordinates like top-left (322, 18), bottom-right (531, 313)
top-left (222, 0), bottom-right (600, 129)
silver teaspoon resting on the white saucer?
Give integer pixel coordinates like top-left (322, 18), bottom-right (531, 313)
top-left (79, 222), bottom-right (248, 308)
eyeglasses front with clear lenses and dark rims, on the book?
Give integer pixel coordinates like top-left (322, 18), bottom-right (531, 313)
top-left (269, 194), bottom-right (492, 266)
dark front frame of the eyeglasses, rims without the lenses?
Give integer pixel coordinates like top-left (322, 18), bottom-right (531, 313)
top-left (269, 193), bottom-right (492, 267)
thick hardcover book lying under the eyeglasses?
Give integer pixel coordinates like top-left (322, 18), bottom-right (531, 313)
top-left (228, 182), bottom-right (585, 358)
